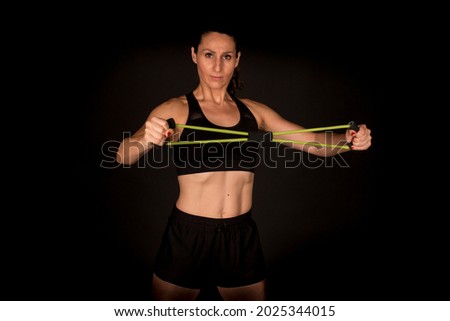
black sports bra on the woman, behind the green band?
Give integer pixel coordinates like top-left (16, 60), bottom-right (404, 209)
top-left (173, 92), bottom-right (261, 175)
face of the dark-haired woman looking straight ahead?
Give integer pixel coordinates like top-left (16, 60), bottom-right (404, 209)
top-left (191, 32), bottom-right (240, 89)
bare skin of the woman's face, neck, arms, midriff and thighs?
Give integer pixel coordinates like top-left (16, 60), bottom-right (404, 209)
top-left (116, 32), bottom-right (372, 300)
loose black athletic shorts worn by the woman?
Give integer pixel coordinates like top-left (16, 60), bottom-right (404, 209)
top-left (155, 207), bottom-right (266, 289)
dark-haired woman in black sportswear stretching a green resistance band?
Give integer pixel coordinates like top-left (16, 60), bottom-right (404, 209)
top-left (116, 30), bottom-right (371, 300)
